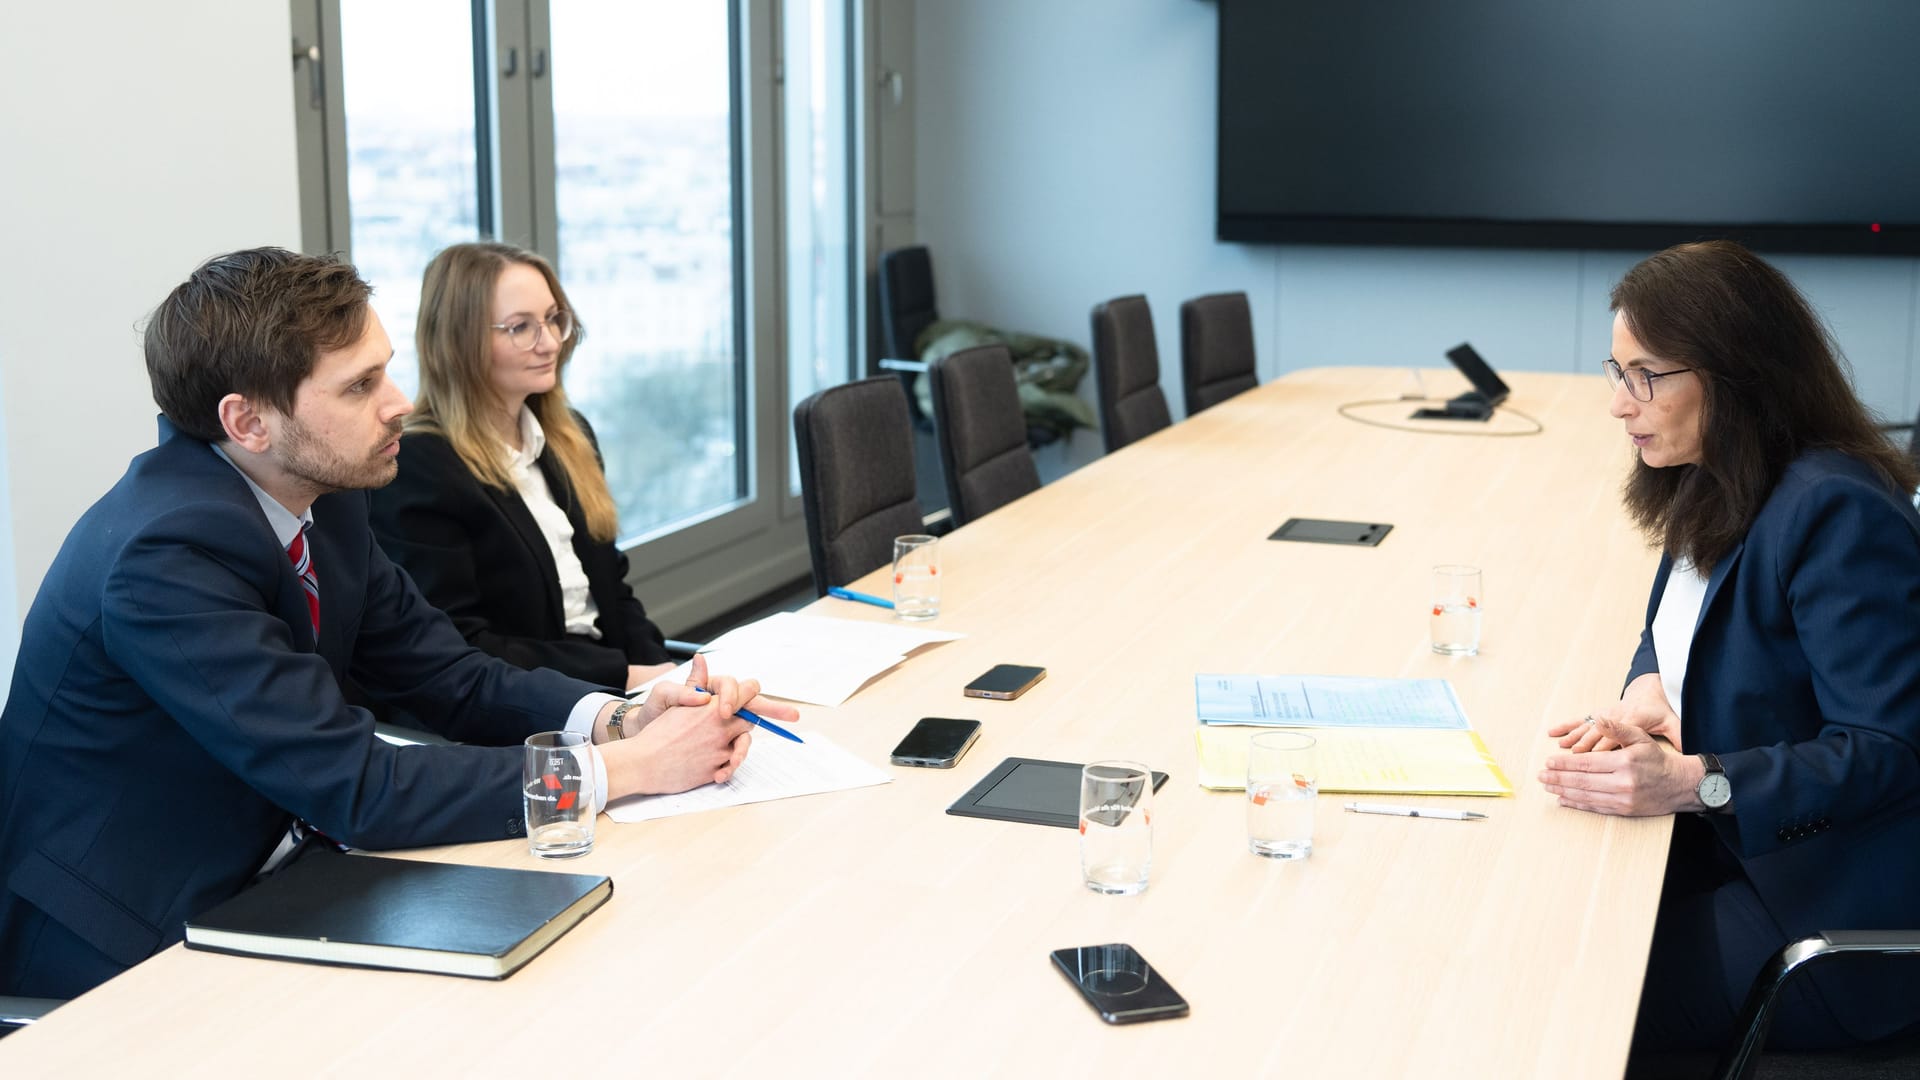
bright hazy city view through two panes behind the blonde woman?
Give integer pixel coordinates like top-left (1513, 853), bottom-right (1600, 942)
top-left (342, 0), bottom-right (747, 536)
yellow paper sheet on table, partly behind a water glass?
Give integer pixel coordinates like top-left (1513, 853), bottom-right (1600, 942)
top-left (1194, 724), bottom-right (1513, 796)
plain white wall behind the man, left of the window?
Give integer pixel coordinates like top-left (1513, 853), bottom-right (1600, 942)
top-left (0, 0), bottom-right (300, 686)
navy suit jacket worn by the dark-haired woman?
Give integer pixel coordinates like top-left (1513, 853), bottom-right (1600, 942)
top-left (1628, 452), bottom-right (1920, 1040)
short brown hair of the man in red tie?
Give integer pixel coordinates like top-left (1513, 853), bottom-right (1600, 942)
top-left (146, 248), bottom-right (372, 442)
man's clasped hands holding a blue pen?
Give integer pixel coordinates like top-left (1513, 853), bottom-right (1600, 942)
top-left (599, 655), bottom-right (801, 799)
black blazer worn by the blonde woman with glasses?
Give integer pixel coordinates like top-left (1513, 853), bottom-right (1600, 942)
top-left (372, 419), bottom-right (670, 688)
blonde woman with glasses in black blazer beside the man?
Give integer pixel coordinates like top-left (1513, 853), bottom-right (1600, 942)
top-left (372, 244), bottom-right (672, 688)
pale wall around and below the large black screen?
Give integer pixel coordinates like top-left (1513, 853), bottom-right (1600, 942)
top-left (914, 0), bottom-right (1920, 467)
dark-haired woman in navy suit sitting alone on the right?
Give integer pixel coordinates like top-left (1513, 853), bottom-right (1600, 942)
top-left (1540, 242), bottom-right (1920, 1051)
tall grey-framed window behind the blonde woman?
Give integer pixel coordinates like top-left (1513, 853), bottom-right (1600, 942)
top-left (290, 0), bottom-right (862, 628)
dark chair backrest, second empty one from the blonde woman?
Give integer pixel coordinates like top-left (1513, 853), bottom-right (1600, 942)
top-left (927, 346), bottom-right (1041, 525)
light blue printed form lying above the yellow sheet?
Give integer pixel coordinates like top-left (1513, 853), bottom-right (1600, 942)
top-left (1194, 675), bottom-right (1471, 730)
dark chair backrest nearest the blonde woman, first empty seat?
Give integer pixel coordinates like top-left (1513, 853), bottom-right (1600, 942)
top-left (793, 375), bottom-right (925, 596)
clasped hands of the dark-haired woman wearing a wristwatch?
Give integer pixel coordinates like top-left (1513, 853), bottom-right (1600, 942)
top-left (1540, 691), bottom-right (1705, 817)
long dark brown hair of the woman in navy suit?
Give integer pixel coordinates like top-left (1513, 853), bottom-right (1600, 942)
top-left (1613, 240), bottom-right (1920, 573)
